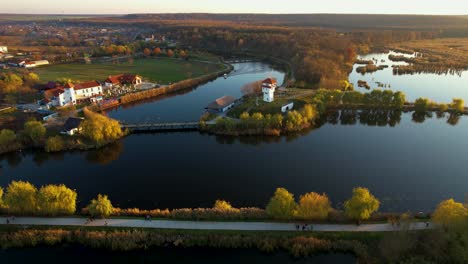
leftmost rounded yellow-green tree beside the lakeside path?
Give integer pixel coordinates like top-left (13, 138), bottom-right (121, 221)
top-left (4, 181), bottom-right (37, 214)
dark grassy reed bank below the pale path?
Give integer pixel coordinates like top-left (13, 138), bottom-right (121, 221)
top-left (0, 226), bottom-right (463, 263)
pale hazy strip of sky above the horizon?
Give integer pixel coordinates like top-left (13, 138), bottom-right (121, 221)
top-left (0, 0), bottom-right (468, 15)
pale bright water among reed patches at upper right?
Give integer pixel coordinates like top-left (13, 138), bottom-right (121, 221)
top-left (349, 52), bottom-right (468, 103)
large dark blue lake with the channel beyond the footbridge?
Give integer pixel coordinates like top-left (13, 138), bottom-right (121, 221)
top-left (0, 63), bottom-right (468, 212)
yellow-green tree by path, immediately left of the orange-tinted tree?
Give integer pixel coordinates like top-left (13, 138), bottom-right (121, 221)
top-left (266, 188), bottom-right (296, 219)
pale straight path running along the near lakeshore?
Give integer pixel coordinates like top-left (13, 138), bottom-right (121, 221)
top-left (0, 217), bottom-right (432, 232)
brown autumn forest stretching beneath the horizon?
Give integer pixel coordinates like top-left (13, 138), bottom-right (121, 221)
top-left (0, 14), bottom-right (468, 89)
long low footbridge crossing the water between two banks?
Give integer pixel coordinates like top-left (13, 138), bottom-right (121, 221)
top-left (121, 121), bottom-right (200, 133)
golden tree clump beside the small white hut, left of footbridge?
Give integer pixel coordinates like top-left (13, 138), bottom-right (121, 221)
top-left (81, 108), bottom-right (123, 144)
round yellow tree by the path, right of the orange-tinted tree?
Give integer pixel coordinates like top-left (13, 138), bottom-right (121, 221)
top-left (344, 187), bottom-right (380, 223)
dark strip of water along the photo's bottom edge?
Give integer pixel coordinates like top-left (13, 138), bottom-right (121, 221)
top-left (0, 247), bottom-right (356, 264)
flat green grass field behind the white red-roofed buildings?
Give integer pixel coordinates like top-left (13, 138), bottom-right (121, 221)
top-left (34, 58), bottom-right (224, 84)
